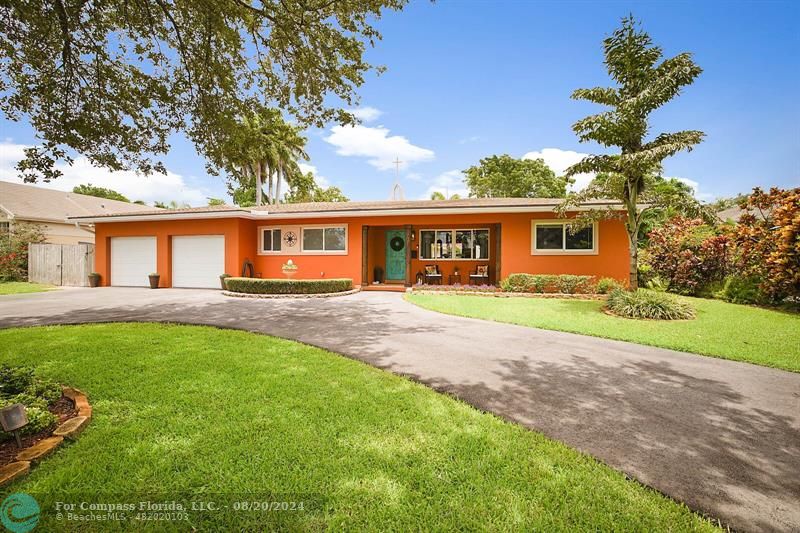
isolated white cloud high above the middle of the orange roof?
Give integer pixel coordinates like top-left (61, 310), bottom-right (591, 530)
top-left (325, 125), bottom-right (434, 170)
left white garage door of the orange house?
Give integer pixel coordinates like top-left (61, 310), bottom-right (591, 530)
top-left (111, 237), bottom-right (156, 287)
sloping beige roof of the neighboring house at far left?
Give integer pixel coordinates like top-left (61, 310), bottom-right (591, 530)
top-left (0, 181), bottom-right (158, 223)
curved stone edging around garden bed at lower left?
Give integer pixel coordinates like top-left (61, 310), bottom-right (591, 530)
top-left (0, 387), bottom-right (92, 487)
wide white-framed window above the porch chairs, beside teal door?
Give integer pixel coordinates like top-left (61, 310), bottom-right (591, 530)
top-left (419, 228), bottom-right (489, 261)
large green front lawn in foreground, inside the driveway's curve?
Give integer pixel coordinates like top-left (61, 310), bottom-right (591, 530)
top-left (0, 324), bottom-right (713, 531)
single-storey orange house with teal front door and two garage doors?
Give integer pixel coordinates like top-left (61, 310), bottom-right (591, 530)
top-left (71, 198), bottom-right (629, 288)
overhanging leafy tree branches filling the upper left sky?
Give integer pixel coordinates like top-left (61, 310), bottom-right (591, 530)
top-left (0, 0), bottom-right (407, 181)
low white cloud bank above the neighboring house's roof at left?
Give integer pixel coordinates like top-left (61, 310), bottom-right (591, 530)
top-left (0, 140), bottom-right (211, 205)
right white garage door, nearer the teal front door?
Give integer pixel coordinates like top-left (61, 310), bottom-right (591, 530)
top-left (172, 235), bottom-right (225, 289)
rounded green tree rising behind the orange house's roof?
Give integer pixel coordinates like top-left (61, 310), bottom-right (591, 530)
top-left (464, 154), bottom-right (571, 198)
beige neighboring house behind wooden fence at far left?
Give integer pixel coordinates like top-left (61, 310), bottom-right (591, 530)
top-left (0, 181), bottom-right (154, 244)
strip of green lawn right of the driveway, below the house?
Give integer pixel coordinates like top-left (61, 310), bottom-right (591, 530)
top-left (407, 294), bottom-right (800, 372)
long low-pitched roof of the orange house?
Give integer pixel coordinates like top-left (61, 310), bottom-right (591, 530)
top-left (69, 198), bottom-right (619, 221)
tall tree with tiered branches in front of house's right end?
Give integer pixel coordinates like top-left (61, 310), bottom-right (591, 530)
top-left (560, 16), bottom-right (704, 289)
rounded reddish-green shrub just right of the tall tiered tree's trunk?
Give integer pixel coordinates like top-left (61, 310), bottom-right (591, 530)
top-left (643, 217), bottom-right (731, 295)
